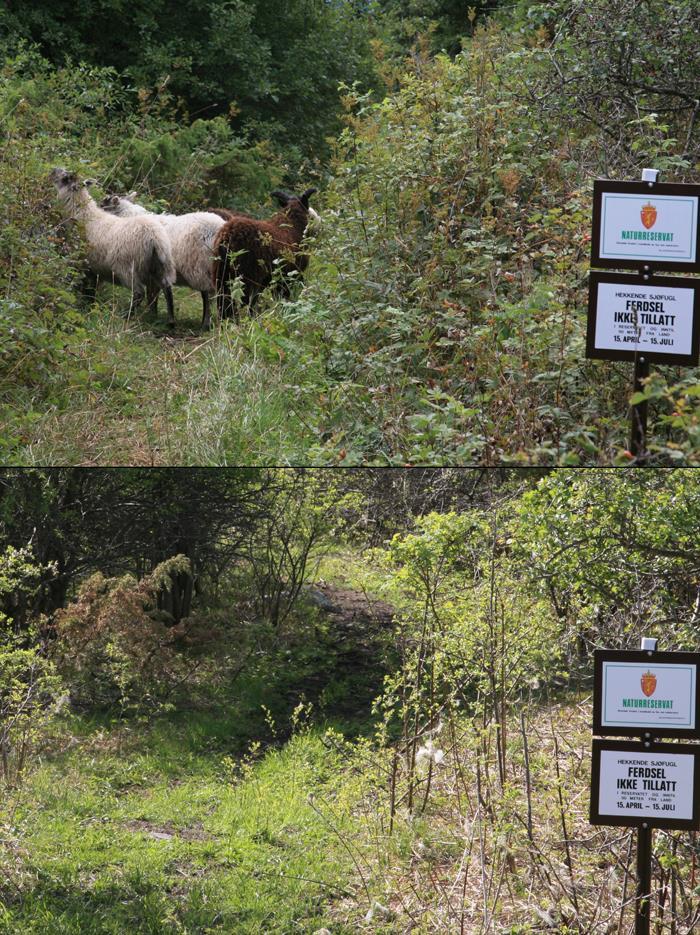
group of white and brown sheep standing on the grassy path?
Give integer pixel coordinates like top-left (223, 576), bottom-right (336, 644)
top-left (50, 168), bottom-right (320, 328)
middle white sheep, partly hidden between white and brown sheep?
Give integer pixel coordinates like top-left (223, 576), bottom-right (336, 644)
top-left (102, 192), bottom-right (230, 329)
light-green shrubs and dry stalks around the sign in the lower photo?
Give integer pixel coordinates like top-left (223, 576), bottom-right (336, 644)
top-left (320, 470), bottom-right (700, 933)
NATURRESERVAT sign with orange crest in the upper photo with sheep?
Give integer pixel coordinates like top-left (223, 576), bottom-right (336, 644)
top-left (591, 180), bottom-right (700, 272)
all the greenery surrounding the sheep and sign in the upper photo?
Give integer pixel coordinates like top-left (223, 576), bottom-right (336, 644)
top-left (0, 0), bottom-right (700, 464)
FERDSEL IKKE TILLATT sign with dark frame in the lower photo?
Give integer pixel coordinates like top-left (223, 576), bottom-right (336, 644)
top-left (591, 740), bottom-right (700, 829)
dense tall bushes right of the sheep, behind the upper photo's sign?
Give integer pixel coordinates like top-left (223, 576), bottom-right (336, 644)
top-left (266, 2), bottom-right (700, 464)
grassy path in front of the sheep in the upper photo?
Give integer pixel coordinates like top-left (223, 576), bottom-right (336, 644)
top-left (14, 288), bottom-right (312, 466)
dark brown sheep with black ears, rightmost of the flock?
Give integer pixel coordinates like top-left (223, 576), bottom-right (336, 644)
top-left (212, 188), bottom-right (320, 320)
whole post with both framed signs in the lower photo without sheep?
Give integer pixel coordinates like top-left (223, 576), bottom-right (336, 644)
top-left (590, 638), bottom-right (700, 935)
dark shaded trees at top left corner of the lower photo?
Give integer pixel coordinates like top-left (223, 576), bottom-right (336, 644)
top-left (0, 468), bottom-right (271, 622)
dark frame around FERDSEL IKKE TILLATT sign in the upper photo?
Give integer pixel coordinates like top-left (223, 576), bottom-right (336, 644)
top-left (586, 270), bottom-right (700, 367)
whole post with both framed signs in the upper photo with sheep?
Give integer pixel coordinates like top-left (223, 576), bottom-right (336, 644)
top-left (586, 169), bottom-right (700, 464)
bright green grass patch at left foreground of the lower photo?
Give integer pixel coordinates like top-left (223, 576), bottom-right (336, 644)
top-left (0, 712), bottom-right (354, 935)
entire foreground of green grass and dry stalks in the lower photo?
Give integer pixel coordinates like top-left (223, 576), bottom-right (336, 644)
top-left (5, 676), bottom-right (700, 935)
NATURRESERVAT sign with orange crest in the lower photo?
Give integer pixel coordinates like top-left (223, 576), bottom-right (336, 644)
top-left (593, 650), bottom-right (700, 738)
